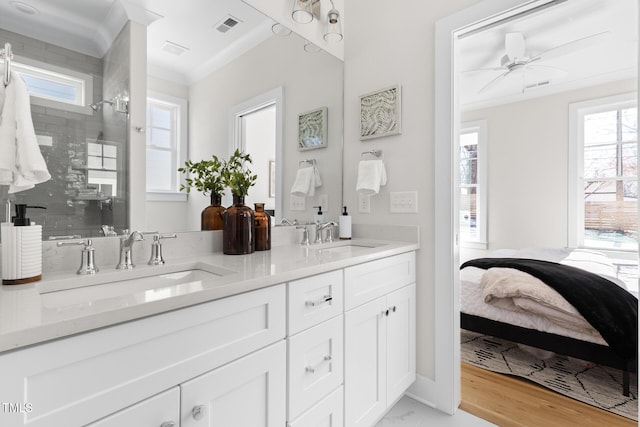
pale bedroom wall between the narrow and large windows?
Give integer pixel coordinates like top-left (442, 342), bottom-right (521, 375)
top-left (461, 80), bottom-right (636, 259)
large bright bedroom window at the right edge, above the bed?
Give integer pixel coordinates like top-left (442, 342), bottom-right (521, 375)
top-left (569, 93), bottom-right (638, 251)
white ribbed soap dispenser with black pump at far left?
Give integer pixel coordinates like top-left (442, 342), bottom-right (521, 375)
top-left (0, 204), bottom-right (46, 285)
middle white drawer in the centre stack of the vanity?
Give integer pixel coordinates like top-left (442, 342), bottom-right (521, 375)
top-left (288, 315), bottom-right (344, 420)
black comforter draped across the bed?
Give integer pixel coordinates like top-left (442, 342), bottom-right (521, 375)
top-left (460, 258), bottom-right (638, 359)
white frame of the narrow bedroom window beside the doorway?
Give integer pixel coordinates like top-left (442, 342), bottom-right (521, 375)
top-left (458, 120), bottom-right (489, 249)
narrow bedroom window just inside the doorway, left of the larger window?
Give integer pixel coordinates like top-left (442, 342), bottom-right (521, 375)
top-left (460, 120), bottom-right (487, 249)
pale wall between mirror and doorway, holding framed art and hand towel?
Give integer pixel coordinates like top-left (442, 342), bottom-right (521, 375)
top-left (344, 0), bottom-right (475, 381)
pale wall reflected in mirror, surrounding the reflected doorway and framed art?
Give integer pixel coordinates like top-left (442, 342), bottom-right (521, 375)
top-left (188, 36), bottom-right (343, 231)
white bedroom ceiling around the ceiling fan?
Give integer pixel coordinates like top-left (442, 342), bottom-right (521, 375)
top-left (459, 0), bottom-right (638, 110)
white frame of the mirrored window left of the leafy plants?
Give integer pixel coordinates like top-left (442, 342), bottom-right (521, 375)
top-left (145, 91), bottom-right (189, 202)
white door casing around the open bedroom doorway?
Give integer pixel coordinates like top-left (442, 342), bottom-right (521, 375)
top-left (434, 0), bottom-right (637, 414)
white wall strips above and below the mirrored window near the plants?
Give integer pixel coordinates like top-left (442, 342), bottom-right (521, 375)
top-left (145, 76), bottom-right (192, 232)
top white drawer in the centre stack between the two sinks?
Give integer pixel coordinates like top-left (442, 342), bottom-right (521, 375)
top-left (288, 270), bottom-right (343, 335)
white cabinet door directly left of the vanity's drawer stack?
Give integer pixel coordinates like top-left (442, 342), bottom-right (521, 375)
top-left (180, 341), bottom-right (286, 427)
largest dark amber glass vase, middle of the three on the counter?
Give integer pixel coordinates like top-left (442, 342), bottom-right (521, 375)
top-left (222, 195), bottom-right (255, 255)
